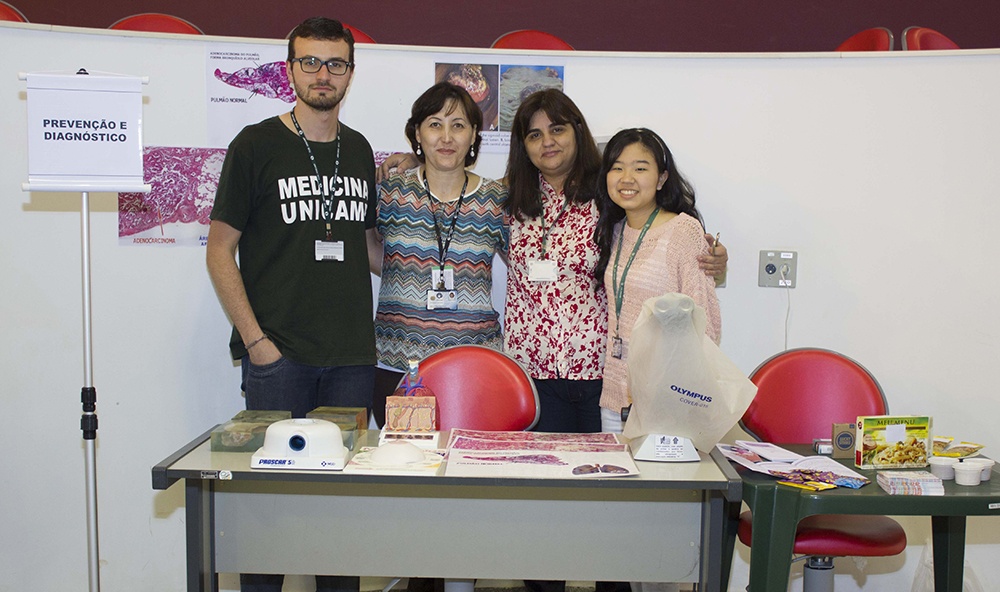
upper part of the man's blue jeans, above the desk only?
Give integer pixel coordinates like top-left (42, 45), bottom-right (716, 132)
top-left (241, 356), bottom-right (375, 417)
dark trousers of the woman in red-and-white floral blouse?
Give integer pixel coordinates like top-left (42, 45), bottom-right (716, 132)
top-left (532, 378), bottom-right (604, 434)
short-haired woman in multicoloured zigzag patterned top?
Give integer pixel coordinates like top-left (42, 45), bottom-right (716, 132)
top-left (369, 82), bottom-right (507, 425)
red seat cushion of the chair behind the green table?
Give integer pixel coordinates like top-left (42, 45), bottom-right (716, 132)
top-left (738, 512), bottom-right (906, 557)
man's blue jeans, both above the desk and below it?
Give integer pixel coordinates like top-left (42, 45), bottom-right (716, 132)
top-left (240, 356), bottom-right (375, 592)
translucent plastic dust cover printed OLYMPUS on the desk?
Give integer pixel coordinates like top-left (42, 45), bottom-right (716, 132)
top-left (624, 293), bottom-right (757, 452)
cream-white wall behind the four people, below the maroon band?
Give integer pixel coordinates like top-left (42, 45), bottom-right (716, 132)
top-left (0, 25), bottom-right (1000, 592)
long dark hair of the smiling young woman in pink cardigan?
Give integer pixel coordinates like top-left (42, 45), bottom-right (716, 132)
top-left (594, 127), bottom-right (705, 284)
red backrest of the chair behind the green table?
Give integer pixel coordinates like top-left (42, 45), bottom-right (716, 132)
top-left (740, 348), bottom-right (888, 444)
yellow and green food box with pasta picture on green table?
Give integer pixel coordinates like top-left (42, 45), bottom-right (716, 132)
top-left (854, 415), bottom-right (932, 469)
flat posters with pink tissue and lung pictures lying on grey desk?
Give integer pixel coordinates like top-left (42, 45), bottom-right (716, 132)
top-left (445, 430), bottom-right (639, 479)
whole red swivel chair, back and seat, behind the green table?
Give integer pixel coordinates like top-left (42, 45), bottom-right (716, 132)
top-left (738, 348), bottom-right (906, 592)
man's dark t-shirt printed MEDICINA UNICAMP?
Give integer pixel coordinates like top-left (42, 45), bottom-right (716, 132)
top-left (211, 117), bottom-right (378, 366)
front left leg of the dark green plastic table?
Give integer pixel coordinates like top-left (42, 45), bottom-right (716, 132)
top-left (750, 486), bottom-right (799, 592)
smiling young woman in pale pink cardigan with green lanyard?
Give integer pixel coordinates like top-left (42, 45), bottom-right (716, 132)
top-left (595, 128), bottom-right (722, 432)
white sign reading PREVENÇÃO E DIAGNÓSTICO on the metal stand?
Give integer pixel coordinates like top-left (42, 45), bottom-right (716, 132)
top-left (25, 71), bottom-right (149, 191)
